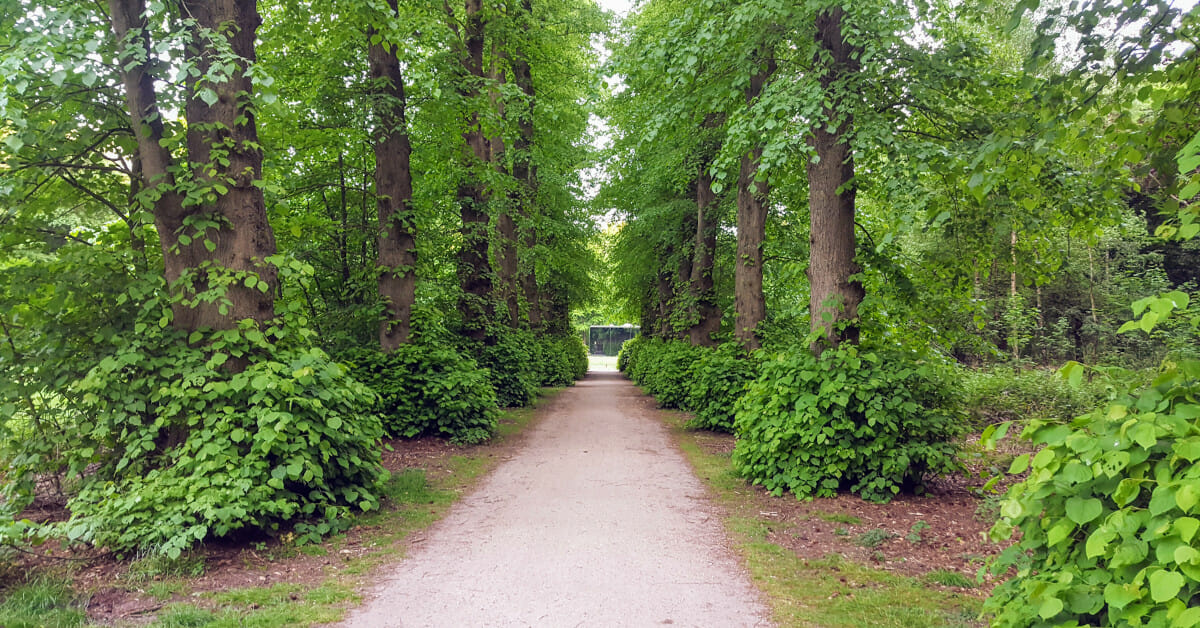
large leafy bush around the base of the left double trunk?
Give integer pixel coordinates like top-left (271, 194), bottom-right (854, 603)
top-left (62, 319), bottom-right (386, 557)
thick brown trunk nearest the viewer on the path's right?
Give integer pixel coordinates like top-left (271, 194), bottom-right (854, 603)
top-left (808, 7), bottom-right (864, 352)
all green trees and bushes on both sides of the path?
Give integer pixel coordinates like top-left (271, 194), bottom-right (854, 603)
top-left (0, 0), bottom-right (1200, 626)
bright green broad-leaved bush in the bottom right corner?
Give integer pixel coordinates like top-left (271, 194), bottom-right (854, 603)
top-left (985, 361), bottom-right (1200, 627)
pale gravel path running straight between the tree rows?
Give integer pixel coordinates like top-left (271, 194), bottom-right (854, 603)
top-left (346, 371), bottom-right (769, 628)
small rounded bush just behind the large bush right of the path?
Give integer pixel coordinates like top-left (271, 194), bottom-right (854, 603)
top-left (688, 342), bottom-right (757, 432)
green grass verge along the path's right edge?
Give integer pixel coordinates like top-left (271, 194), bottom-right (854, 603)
top-left (676, 420), bottom-right (980, 628)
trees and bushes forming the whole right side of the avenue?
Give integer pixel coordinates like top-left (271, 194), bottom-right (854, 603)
top-left (596, 0), bottom-right (1200, 626)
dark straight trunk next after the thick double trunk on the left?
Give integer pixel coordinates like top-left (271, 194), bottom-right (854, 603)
top-left (367, 0), bottom-right (416, 352)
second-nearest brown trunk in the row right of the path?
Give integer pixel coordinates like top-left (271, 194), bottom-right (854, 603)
top-left (733, 58), bottom-right (775, 351)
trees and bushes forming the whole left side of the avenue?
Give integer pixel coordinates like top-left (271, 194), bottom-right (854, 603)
top-left (0, 0), bottom-right (607, 556)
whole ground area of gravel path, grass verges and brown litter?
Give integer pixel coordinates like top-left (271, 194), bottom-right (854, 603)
top-left (0, 365), bottom-right (1010, 627)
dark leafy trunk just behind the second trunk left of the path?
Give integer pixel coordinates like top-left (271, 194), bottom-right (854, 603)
top-left (457, 0), bottom-right (496, 341)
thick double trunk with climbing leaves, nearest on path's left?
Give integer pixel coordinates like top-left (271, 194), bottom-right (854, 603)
top-left (109, 0), bottom-right (278, 330)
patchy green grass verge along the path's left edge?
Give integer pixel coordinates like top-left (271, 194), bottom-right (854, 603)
top-left (0, 389), bottom-right (559, 628)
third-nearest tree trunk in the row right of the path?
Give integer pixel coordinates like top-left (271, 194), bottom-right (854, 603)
top-left (688, 165), bottom-right (721, 347)
